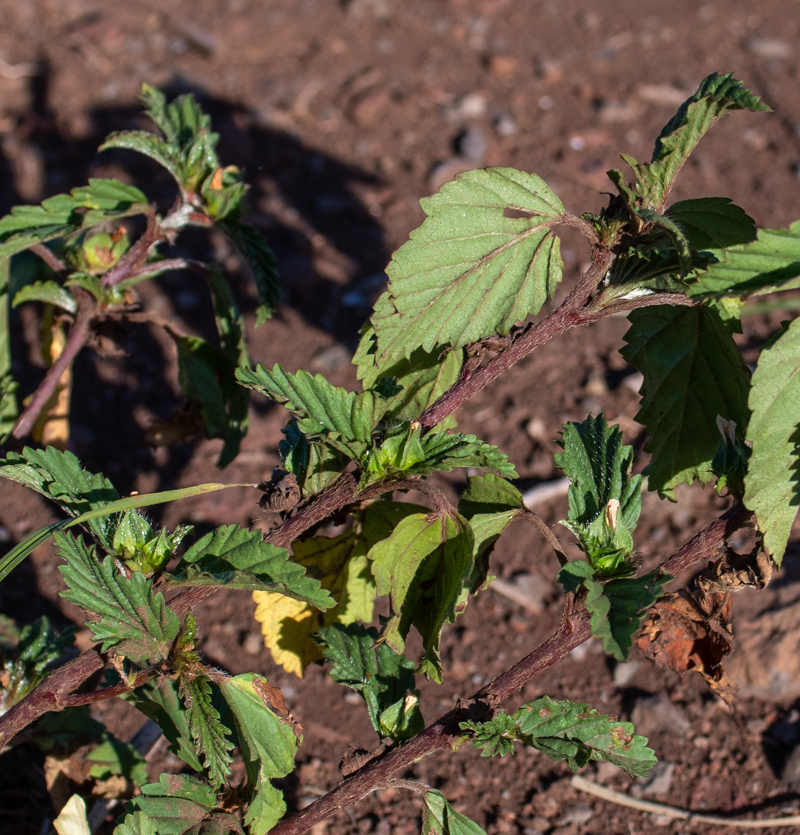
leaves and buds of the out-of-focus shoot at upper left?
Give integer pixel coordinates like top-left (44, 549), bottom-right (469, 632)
top-left (0, 85), bottom-right (278, 466)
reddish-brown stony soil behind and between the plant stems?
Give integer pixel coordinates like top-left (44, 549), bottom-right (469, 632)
top-left (0, 0), bottom-right (800, 835)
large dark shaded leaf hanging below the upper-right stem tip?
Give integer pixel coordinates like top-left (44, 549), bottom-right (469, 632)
top-left (621, 306), bottom-right (750, 498)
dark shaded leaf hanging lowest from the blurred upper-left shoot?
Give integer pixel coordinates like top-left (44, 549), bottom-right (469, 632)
top-left (175, 336), bottom-right (249, 467)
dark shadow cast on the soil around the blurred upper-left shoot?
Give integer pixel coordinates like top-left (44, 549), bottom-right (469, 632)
top-left (0, 72), bottom-right (388, 496)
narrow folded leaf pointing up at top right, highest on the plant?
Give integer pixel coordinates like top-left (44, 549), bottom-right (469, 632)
top-left (623, 73), bottom-right (769, 212)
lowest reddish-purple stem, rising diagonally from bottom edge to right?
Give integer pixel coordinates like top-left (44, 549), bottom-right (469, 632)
top-left (270, 505), bottom-right (751, 835)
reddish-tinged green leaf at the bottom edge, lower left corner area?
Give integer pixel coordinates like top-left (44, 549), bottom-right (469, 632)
top-left (122, 774), bottom-right (222, 835)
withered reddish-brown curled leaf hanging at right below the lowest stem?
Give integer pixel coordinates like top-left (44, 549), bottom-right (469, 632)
top-left (636, 591), bottom-right (736, 702)
